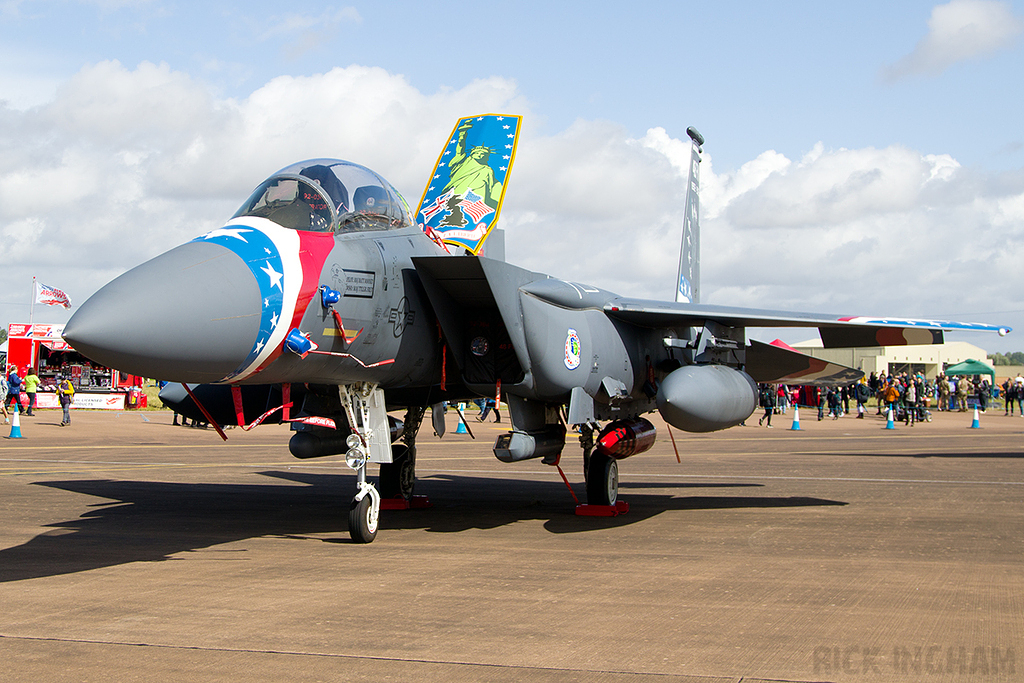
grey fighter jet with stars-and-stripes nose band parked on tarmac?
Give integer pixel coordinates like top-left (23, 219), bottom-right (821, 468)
top-left (65, 115), bottom-right (1009, 543)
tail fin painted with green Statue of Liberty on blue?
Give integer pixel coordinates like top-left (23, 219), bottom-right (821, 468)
top-left (416, 114), bottom-right (522, 254)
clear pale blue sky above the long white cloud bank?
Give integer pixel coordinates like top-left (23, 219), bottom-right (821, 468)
top-left (8, 0), bottom-right (1024, 169)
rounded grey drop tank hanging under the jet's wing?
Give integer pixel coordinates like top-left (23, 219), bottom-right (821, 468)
top-left (655, 366), bottom-right (758, 432)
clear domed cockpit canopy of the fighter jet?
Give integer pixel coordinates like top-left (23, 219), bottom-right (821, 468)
top-left (233, 159), bottom-right (414, 232)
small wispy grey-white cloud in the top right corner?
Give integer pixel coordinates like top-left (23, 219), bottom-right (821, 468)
top-left (881, 0), bottom-right (1024, 83)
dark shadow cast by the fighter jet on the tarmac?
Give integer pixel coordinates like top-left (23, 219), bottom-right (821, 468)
top-left (0, 471), bottom-right (846, 582)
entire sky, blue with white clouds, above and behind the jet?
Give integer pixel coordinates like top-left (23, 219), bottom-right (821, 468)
top-left (0, 0), bottom-right (1024, 351)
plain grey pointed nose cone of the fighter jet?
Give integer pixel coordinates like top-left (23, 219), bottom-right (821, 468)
top-left (63, 242), bottom-right (261, 383)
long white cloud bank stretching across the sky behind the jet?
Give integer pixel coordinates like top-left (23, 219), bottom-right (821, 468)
top-left (0, 61), bottom-right (1024, 348)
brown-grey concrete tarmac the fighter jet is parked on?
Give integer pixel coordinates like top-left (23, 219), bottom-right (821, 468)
top-left (0, 409), bottom-right (1024, 683)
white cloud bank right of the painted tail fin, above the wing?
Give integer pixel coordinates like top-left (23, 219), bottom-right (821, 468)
top-left (503, 127), bottom-right (1024, 336)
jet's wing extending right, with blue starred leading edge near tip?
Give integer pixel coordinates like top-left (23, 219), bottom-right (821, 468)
top-left (604, 298), bottom-right (1010, 348)
